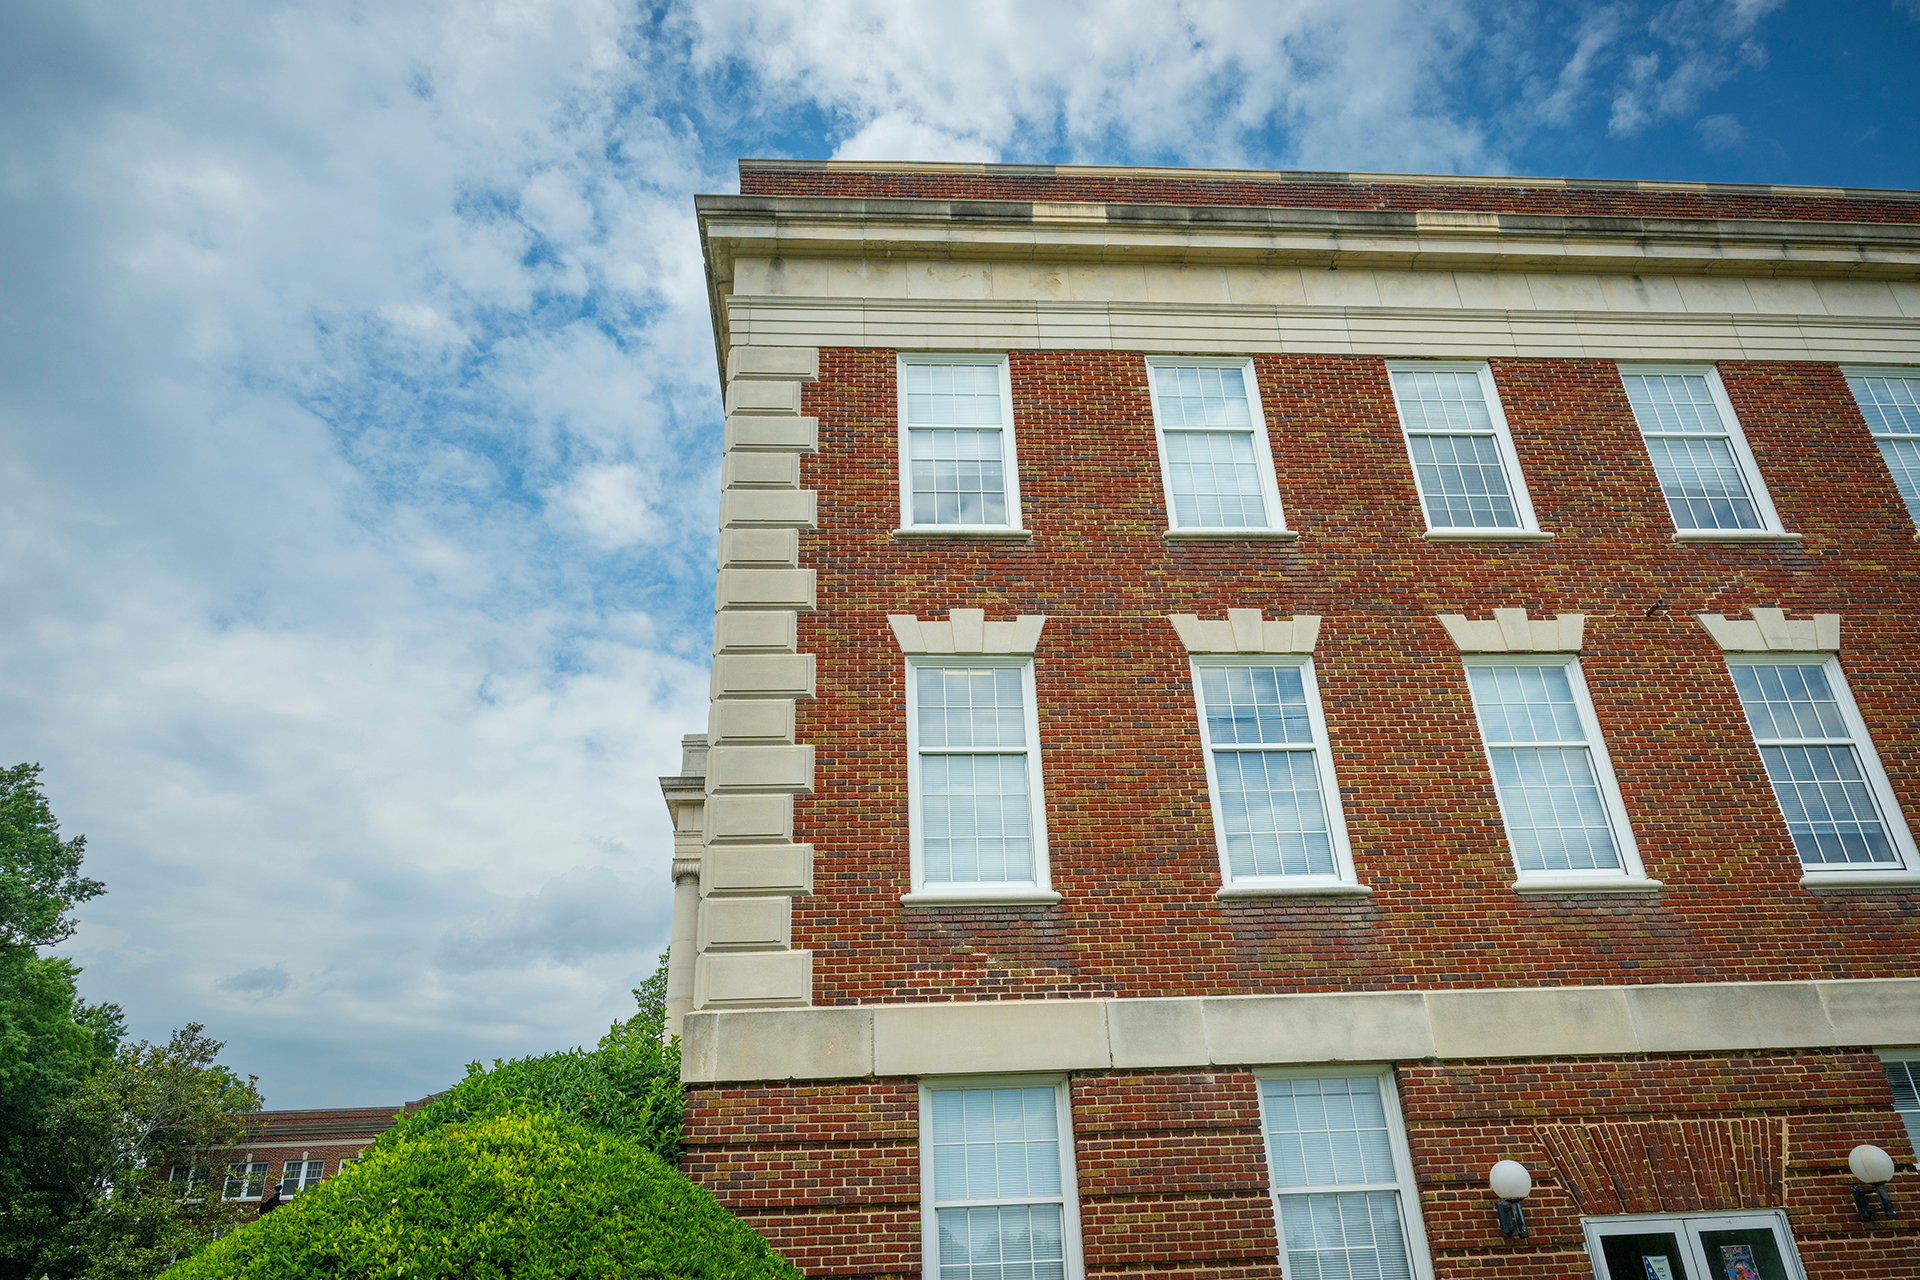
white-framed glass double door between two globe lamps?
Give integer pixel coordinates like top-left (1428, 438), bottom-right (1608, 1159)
top-left (1582, 1211), bottom-right (1805, 1280)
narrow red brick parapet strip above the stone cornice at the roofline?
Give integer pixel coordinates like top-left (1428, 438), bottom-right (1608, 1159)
top-left (739, 167), bottom-right (1920, 223)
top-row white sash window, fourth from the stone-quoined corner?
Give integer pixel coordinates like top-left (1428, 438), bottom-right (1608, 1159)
top-left (1620, 365), bottom-right (1782, 539)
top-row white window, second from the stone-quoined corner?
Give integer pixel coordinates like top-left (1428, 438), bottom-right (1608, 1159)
top-left (1146, 357), bottom-right (1284, 530)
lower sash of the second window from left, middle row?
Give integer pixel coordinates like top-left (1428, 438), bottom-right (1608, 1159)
top-left (1213, 750), bottom-right (1334, 877)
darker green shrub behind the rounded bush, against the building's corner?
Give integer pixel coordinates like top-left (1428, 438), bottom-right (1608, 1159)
top-left (374, 956), bottom-right (682, 1165)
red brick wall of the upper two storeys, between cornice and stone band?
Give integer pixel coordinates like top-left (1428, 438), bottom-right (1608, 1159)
top-left (793, 349), bottom-right (1920, 1004)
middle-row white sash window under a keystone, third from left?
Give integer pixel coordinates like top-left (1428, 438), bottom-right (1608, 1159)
top-left (1467, 654), bottom-right (1642, 887)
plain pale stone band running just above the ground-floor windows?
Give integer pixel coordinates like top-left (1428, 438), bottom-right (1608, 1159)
top-left (680, 979), bottom-right (1920, 1084)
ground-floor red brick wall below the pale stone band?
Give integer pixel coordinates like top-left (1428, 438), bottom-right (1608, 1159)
top-left (682, 1052), bottom-right (1920, 1280)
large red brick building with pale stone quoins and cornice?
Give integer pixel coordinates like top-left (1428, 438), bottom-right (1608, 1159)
top-left (664, 161), bottom-right (1920, 1280)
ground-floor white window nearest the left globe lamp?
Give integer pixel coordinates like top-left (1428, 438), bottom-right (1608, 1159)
top-left (1256, 1069), bottom-right (1432, 1280)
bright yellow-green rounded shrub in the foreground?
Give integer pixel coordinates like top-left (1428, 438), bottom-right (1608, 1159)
top-left (167, 1115), bottom-right (801, 1280)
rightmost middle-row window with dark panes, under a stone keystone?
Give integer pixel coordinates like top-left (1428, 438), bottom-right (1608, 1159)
top-left (1728, 654), bottom-right (1920, 879)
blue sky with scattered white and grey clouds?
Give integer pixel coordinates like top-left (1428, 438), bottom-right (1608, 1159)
top-left (0, 0), bottom-right (1920, 1107)
